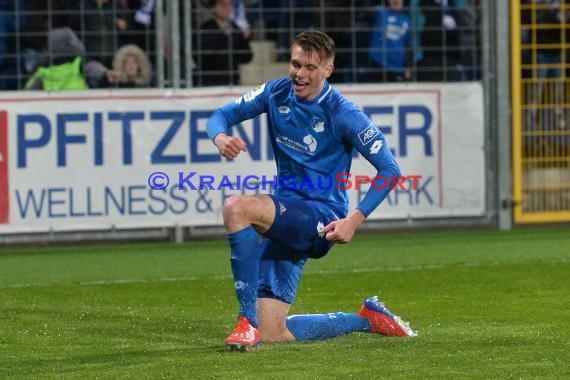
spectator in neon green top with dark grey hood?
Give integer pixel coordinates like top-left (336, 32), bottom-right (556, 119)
top-left (25, 28), bottom-right (88, 91)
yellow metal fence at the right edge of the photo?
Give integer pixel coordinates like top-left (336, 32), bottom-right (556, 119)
top-left (511, 0), bottom-right (570, 223)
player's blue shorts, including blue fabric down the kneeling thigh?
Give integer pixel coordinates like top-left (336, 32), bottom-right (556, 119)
top-left (257, 195), bottom-right (338, 304)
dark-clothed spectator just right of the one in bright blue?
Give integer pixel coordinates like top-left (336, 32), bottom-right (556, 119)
top-left (418, 0), bottom-right (458, 82)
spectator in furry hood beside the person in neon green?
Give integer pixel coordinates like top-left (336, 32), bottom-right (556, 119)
top-left (85, 44), bottom-right (151, 88)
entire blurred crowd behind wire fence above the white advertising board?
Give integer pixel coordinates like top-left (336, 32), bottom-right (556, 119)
top-left (0, 0), bottom-right (490, 90)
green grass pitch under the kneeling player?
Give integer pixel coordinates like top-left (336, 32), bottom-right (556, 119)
top-left (0, 227), bottom-right (570, 379)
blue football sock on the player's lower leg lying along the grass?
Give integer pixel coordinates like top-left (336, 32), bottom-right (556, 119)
top-left (286, 313), bottom-right (370, 341)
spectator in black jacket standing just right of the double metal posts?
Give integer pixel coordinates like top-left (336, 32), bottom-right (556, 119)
top-left (194, 0), bottom-right (253, 86)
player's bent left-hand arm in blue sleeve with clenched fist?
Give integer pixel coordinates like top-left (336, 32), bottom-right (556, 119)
top-left (206, 85), bottom-right (269, 158)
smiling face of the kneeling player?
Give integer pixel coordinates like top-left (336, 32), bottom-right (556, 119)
top-left (289, 46), bottom-right (333, 100)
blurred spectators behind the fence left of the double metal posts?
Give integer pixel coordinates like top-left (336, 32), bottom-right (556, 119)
top-left (0, 0), bottom-right (154, 91)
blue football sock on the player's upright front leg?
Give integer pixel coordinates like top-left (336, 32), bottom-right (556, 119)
top-left (228, 226), bottom-right (260, 327)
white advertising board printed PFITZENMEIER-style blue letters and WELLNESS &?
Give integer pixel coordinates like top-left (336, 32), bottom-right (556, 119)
top-left (0, 83), bottom-right (485, 233)
